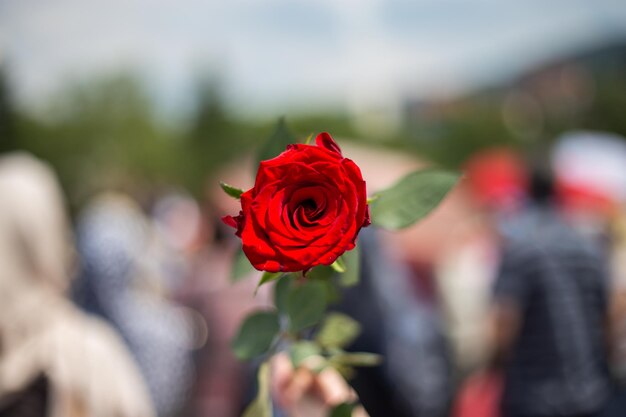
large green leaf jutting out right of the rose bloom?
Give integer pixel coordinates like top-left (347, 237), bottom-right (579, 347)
top-left (370, 169), bottom-right (459, 230)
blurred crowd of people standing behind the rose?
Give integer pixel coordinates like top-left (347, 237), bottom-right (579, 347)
top-left (0, 127), bottom-right (626, 417)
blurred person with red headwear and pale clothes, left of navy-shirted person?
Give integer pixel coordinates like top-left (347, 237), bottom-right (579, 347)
top-left (436, 148), bottom-right (528, 383)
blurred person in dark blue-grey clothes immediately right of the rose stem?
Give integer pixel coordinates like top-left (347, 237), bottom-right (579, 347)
top-left (337, 229), bottom-right (452, 417)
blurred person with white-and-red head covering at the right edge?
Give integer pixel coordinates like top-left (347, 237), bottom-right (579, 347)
top-left (552, 131), bottom-right (626, 416)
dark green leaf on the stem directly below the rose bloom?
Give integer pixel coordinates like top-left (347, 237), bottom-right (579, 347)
top-left (287, 281), bottom-right (326, 332)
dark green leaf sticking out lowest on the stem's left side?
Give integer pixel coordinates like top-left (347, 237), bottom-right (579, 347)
top-left (232, 311), bottom-right (280, 360)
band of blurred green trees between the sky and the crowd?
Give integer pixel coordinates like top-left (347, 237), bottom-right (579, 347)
top-left (0, 61), bottom-right (626, 208)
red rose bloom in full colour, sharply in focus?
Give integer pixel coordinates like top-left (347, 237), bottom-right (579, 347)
top-left (222, 133), bottom-right (370, 272)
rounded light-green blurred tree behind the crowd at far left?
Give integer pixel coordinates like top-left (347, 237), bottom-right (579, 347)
top-left (17, 75), bottom-right (180, 206)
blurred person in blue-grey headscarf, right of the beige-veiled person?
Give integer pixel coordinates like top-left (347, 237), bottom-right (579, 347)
top-left (74, 193), bottom-right (195, 417)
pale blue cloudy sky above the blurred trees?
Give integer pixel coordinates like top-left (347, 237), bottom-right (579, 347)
top-left (0, 0), bottom-right (626, 115)
